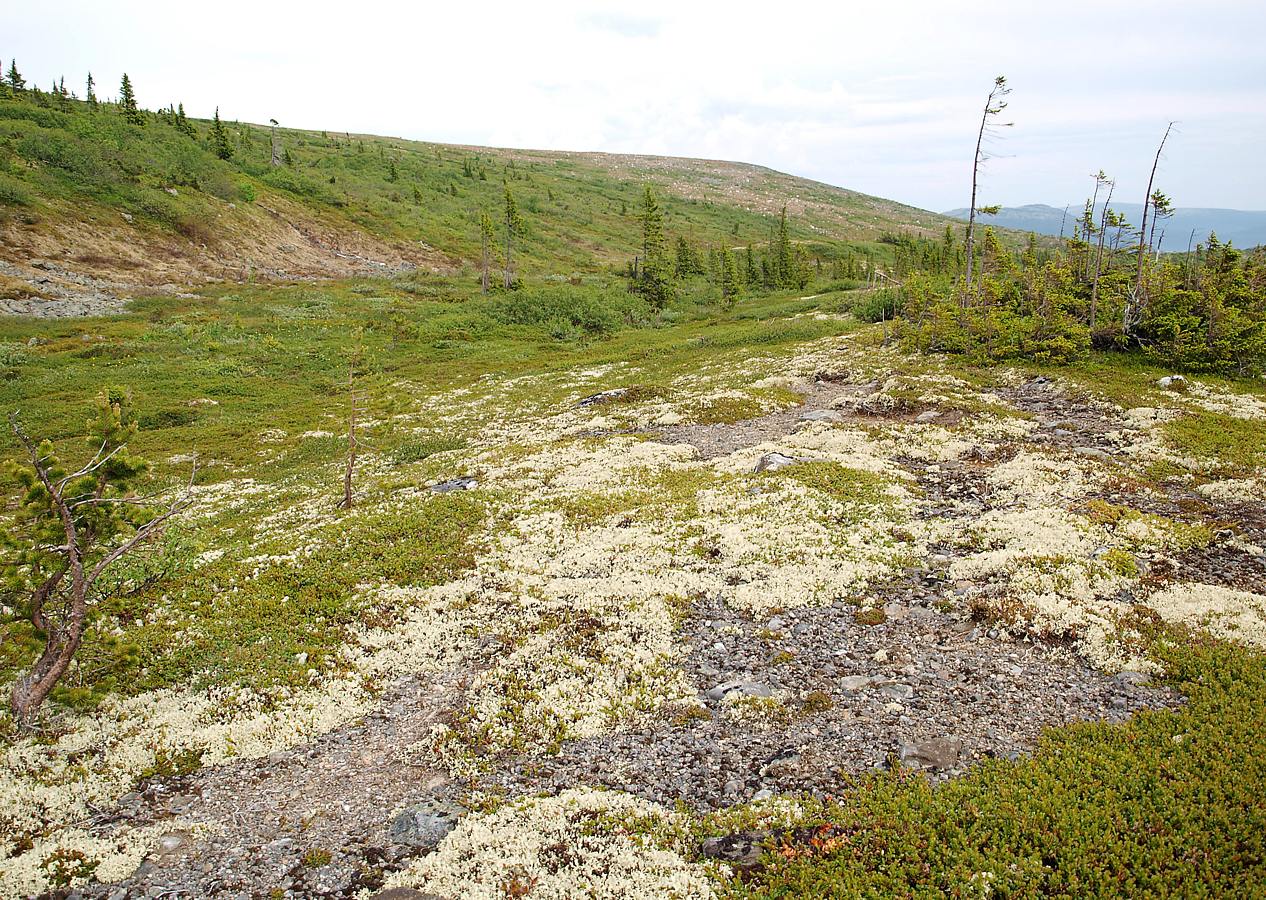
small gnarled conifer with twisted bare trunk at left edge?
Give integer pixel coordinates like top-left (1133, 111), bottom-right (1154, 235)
top-left (3, 389), bottom-right (196, 724)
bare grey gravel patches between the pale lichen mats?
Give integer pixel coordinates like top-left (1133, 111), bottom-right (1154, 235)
top-left (42, 349), bottom-right (1266, 900)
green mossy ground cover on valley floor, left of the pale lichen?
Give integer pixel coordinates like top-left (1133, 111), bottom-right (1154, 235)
top-left (0, 276), bottom-right (852, 705)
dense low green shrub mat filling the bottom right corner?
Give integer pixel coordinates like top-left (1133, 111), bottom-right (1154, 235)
top-left (727, 635), bottom-right (1266, 897)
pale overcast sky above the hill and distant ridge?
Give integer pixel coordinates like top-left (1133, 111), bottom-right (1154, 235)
top-left (9, 0), bottom-right (1266, 210)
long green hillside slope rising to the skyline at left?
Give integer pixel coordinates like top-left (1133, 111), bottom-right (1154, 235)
top-left (0, 94), bottom-right (947, 284)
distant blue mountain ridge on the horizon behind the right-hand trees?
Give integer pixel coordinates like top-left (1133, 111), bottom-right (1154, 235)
top-left (944, 201), bottom-right (1266, 253)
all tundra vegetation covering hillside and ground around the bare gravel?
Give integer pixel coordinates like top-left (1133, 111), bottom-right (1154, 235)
top-left (0, 62), bottom-right (1266, 897)
